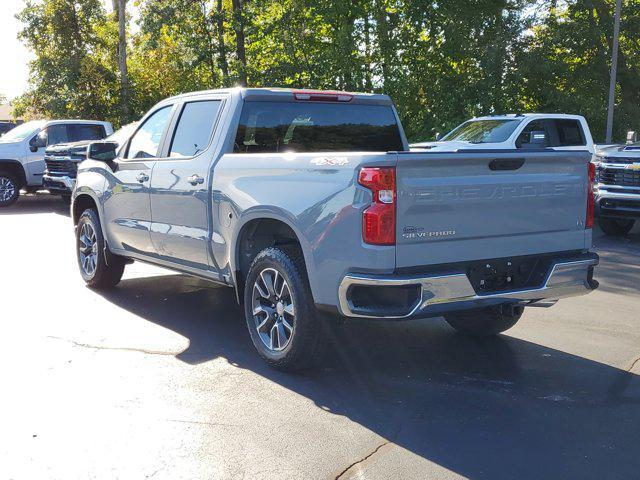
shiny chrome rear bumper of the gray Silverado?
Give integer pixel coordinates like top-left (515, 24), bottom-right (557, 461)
top-left (338, 257), bottom-right (598, 318)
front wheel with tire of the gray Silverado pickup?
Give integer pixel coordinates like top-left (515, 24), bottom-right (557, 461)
top-left (76, 208), bottom-right (125, 289)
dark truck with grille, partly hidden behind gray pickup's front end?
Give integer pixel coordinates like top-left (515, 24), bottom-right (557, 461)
top-left (42, 122), bottom-right (137, 197)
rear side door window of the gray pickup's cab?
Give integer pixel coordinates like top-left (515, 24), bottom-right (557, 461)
top-left (169, 100), bottom-right (222, 157)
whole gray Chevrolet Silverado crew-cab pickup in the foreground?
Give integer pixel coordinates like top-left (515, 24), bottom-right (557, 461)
top-left (71, 88), bottom-right (598, 369)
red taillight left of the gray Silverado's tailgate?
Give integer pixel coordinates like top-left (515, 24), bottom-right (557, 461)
top-left (358, 168), bottom-right (396, 245)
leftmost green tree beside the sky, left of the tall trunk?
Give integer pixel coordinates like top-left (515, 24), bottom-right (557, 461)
top-left (15, 0), bottom-right (119, 123)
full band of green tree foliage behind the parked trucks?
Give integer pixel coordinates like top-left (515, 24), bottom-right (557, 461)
top-left (12, 0), bottom-right (640, 139)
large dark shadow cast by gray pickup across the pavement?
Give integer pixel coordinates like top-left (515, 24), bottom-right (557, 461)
top-left (97, 275), bottom-right (640, 479)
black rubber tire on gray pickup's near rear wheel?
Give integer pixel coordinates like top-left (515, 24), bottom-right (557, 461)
top-left (244, 247), bottom-right (328, 371)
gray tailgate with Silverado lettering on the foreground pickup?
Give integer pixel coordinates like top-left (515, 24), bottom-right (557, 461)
top-left (396, 150), bottom-right (591, 268)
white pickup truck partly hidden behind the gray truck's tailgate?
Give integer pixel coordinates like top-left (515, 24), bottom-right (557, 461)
top-left (410, 113), bottom-right (594, 153)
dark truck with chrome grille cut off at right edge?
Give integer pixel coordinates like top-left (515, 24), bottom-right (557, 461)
top-left (594, 138), bottom-right (640, 236)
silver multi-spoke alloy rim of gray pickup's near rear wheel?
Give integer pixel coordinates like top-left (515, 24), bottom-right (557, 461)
top-left (252, 268), bottom-right (295, 351)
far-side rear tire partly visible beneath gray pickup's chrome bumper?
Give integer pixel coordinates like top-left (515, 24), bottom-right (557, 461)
top-left (444, 305), bottom-right (524, 337)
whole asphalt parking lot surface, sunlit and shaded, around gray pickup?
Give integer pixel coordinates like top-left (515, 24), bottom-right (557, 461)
top-left (0, 195), bottom-right (640, 480)
